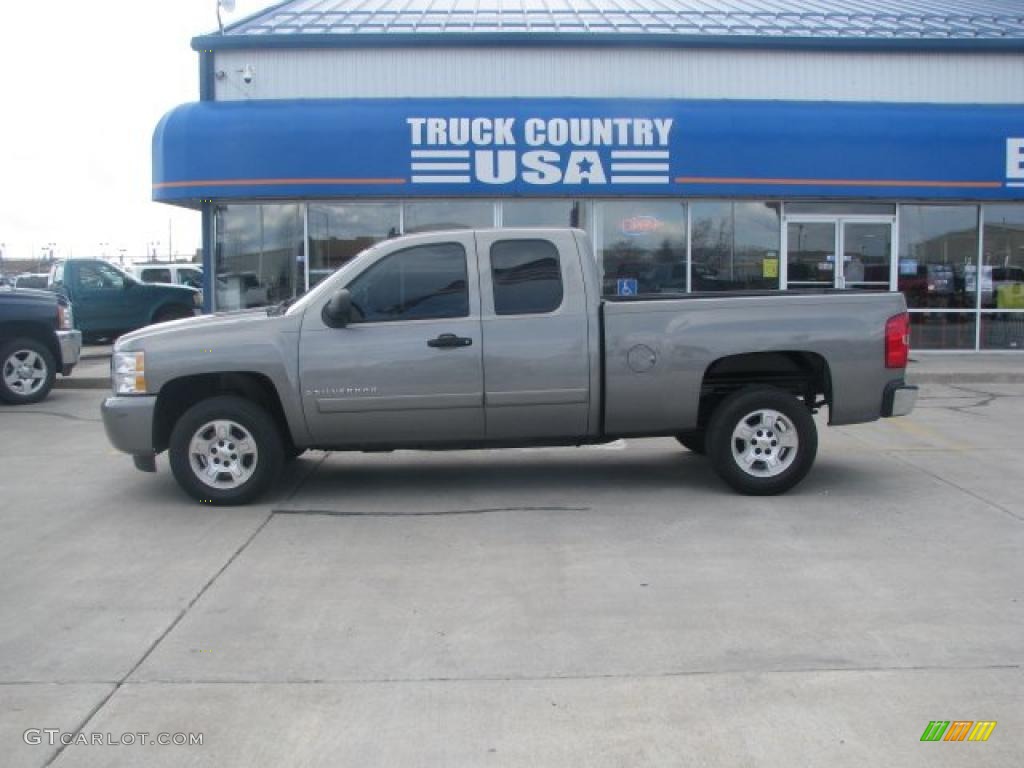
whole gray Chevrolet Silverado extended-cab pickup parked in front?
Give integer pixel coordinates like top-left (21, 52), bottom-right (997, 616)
top-left (102, 229), bottom-right (916, 504)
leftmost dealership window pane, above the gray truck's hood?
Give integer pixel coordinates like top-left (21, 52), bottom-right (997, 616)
top-left (215, 204), bottom-right (304, 309)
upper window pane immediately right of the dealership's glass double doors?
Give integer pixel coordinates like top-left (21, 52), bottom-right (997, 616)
top-left (898, 205), bottom-right (978, 309)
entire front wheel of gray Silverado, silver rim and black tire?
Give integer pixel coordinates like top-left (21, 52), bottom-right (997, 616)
top-left (168, 395), bottom-right (284, 506)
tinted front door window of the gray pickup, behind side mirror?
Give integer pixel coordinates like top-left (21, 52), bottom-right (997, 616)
top-left (348, 243), bottom-right (469, 323)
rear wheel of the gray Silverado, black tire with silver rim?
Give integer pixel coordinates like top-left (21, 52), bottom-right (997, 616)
top-left (708, 386), bottom-right (818, 496)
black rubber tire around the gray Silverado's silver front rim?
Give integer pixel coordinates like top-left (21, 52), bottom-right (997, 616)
top-left (168, 395), bottom-right (284, 506)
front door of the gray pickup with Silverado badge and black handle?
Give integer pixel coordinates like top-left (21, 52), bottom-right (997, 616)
top-left (299, 232), bottom-right (484, 446)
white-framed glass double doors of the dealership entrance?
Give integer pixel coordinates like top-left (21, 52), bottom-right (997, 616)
top-left (785, 216), bottom-right (893, 291)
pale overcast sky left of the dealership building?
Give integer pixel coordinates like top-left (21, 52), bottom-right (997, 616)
top-left (0, 0), bottom-right (272, 260)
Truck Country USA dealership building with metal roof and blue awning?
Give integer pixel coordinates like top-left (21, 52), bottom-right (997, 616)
top-left (153, 0), bottom-right (1024, 350)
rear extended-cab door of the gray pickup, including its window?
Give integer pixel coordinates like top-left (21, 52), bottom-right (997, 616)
top-left (476, 229), bottom-right (591, 440)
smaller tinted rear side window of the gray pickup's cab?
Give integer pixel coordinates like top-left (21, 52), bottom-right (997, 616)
top-left (490, 240), bottom-right (562, 314)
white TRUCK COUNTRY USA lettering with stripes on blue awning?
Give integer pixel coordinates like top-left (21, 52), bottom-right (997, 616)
top-left (406, 117), bottom-right (674, 185)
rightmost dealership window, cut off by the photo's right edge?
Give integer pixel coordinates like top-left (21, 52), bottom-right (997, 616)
top-left (981, 205), bottom-right (1024, 349)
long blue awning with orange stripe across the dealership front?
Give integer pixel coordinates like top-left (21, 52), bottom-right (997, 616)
top-left (153, 99), bottom-right (1024, 206)
